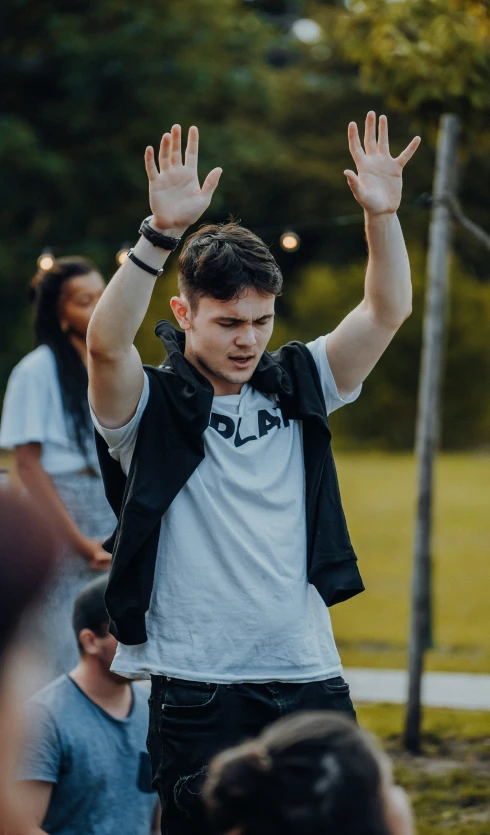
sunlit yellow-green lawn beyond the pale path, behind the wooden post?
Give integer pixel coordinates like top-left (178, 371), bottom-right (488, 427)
top-left (331, 452), bottom-right (490, 673)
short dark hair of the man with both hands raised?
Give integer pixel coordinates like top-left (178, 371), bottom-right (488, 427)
top-left (179, 221), bottom-right (282, 312)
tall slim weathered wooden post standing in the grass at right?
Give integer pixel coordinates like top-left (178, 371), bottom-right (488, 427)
top-left (405, 114), bottom-right (459, 753)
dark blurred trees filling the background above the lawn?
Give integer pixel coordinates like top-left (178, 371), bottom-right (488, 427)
top-left (0, 0), bottom-right (490, 451)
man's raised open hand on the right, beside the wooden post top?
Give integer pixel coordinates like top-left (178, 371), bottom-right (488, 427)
top-left (344, 110), bottom-right (421, 215)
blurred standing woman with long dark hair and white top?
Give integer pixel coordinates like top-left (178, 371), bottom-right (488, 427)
top-left (0, 257), bottom-right (115, 677)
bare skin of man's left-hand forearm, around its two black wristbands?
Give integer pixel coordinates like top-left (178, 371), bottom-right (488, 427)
top-left (87, 225), bottom-right (181, 357)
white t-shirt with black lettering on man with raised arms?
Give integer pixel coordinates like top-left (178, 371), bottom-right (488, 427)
top-left (92, 336), bottom-right (360, 683)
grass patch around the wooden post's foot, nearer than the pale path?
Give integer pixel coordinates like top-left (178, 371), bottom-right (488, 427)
top-left (357, 704), bottom-right (490, 835)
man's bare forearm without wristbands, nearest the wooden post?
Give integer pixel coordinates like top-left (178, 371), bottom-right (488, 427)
top-left (364, 212), bottom-right (412, 328)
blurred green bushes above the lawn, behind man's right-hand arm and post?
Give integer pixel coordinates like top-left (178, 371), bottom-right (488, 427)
top-left (284, 245), bottom-right (490, 449)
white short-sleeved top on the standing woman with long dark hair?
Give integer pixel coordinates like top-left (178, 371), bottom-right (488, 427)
top-left (0, 345), bottom-right (100, 475)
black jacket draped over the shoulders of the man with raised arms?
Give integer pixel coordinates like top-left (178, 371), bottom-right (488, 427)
top-left (96, 321), bottom-right (364, 644)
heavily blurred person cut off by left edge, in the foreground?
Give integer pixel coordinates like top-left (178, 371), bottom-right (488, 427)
top-left (0, 489), bottom-right (59, 831)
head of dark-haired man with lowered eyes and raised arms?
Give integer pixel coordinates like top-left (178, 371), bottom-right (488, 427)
top-left (171, 223), bottom-right (282, 393)
